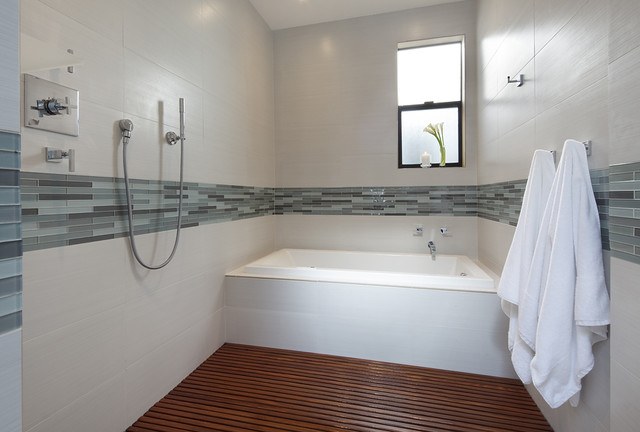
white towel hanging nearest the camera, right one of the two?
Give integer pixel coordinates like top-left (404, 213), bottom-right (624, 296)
top-left (520, 140), bottom-right (609, 408)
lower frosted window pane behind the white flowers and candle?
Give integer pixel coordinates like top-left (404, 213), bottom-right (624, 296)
top-left (401, 108), bottom-right (460, 165)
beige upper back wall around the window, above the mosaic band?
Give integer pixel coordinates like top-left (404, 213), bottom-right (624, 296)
top-left (275, 2), bottom-right (476, 187)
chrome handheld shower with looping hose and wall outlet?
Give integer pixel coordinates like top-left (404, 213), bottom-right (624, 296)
top-left (118, 98), bottom-right (185, 270)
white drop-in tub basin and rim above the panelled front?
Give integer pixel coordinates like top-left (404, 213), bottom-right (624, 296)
top-left (228, 249), bottom-right (496, 292)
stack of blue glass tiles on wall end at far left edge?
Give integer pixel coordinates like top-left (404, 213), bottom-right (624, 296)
top-left (0, 132), bottom-right (22, 335)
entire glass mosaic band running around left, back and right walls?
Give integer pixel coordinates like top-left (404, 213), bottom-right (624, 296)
top-left (21, 170), bottom-right (609, 256)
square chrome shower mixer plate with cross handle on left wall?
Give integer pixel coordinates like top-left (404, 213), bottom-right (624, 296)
top-left (24, 74), bottom-right (79, 136)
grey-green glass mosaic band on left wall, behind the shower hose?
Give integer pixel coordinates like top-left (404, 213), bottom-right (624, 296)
top-left (21, 172), bottom-right (274, 251)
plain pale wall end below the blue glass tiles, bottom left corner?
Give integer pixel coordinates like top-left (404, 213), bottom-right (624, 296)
top-left (0, 330), bottom-right (22, 432)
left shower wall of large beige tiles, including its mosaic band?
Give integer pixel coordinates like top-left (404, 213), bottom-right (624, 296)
top-left (19, 0), bottom-right (275, 432)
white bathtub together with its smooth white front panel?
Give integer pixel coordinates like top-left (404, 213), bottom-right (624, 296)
top-left (224, 249), bottom-right (515, 378)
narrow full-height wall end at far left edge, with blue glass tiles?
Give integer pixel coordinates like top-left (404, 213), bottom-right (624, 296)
top-left (0, 0), bottom-right (22, 432)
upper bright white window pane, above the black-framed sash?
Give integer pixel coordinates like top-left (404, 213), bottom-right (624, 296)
top-left (398, 42), bottom-right (462, 105)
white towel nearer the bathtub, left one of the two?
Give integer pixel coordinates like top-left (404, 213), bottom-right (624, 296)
top-left (498, 150), bottom-right (556, 384)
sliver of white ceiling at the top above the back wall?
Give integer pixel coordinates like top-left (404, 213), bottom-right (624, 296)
top-left (250, 0), bottom-right (460, 30)
